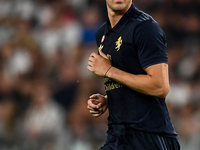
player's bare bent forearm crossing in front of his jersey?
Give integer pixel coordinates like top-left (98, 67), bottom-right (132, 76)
top-left (107, 64), bottom-right (169, 98)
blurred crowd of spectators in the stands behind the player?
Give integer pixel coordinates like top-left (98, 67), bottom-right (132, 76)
top-left (0, 0), bottom-right (200, 150)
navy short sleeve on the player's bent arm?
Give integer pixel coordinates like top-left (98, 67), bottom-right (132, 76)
top-left (133, 20), bottom-right (168, 69)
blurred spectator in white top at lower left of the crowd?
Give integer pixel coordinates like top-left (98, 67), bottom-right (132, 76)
top-left (24, 79), bottom-right (65, 150)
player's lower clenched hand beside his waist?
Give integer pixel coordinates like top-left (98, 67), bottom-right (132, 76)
top-left (87, 94), bottom-right (108, 117)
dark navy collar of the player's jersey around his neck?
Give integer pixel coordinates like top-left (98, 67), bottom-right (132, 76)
top-left (105, 4), bottom-right (135, 34)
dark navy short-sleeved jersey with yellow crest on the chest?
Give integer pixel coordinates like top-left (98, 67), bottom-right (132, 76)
top-left (96, 5), bottom-right (176, 137)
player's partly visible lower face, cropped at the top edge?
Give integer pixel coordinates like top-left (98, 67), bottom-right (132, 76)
top-left (106, 0), bottom-right (132, 13)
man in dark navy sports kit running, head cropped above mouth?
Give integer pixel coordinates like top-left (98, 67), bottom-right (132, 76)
top-left (87, 0), bottom-right (180, 150)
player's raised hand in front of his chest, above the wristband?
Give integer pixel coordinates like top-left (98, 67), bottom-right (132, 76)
top-left (87, 51), bottom-right (112, 76)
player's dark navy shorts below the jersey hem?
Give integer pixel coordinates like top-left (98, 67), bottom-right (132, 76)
top-left (100, 125), bottom-right (180, 150)
